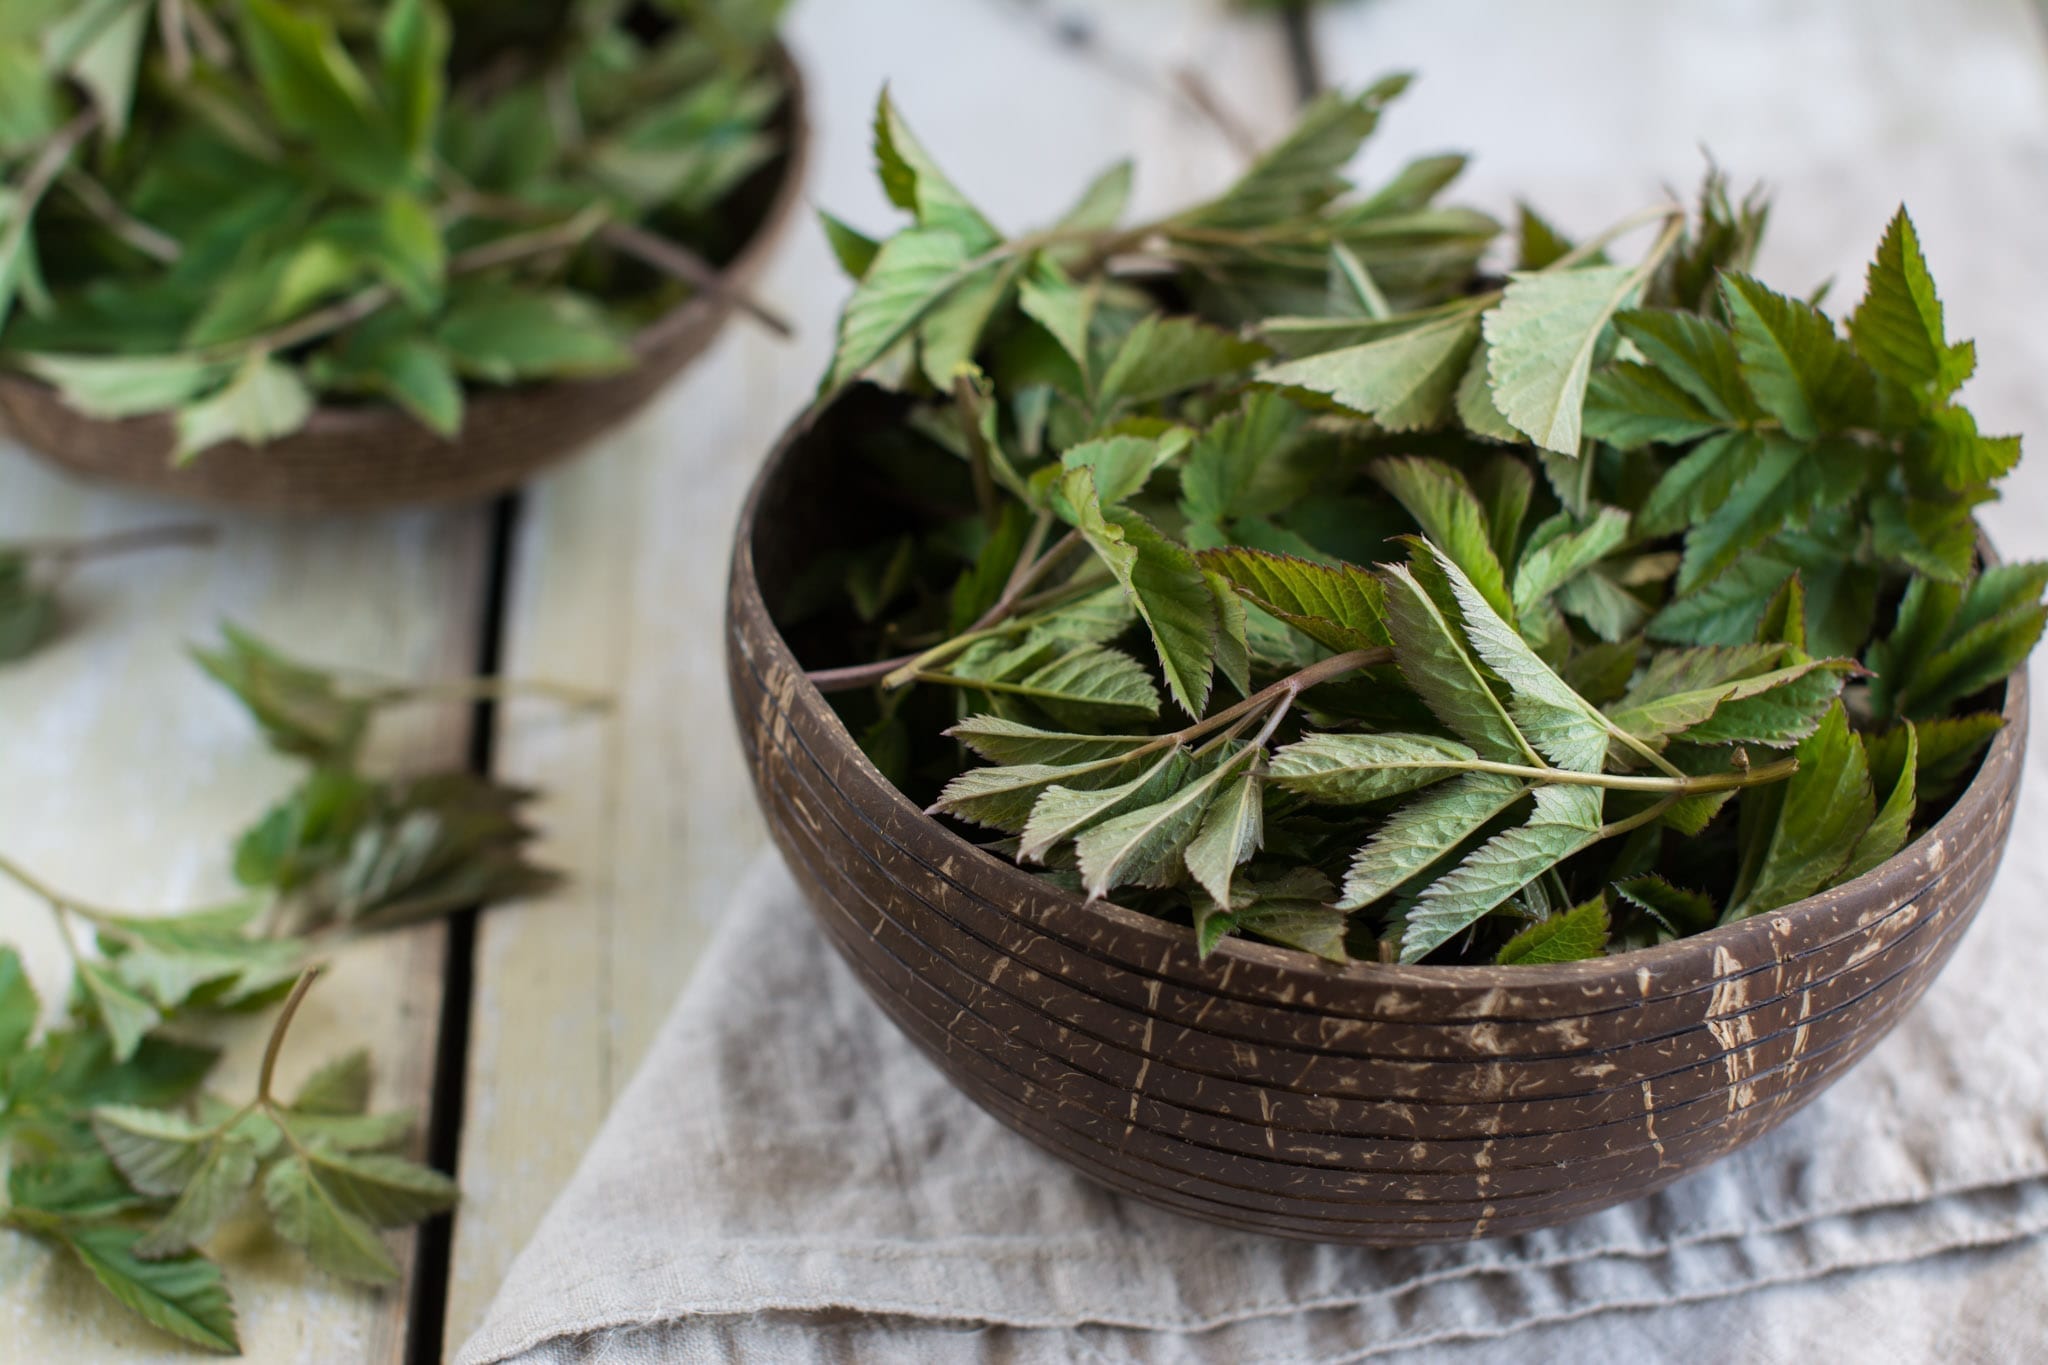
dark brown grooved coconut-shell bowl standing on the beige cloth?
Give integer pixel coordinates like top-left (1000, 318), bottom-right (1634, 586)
top-left (727, 393), bottom-right (2028, 1244)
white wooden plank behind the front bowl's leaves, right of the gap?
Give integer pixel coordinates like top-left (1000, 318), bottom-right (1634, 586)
top-left (1315, 0), bottom-right (2048, 555)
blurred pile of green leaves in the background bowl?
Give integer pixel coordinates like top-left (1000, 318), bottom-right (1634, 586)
top-left (0, 0), bottom-right (784, 456)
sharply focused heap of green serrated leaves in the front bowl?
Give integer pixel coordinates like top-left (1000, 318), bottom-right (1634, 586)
top-left (778, 78), bottom-right (2048, 964)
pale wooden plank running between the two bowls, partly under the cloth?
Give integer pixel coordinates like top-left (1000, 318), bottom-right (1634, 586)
top-left (446, 0), bottom-right (1292, 1351)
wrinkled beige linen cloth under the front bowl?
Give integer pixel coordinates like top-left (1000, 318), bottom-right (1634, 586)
top-left (457, 753), bottom-right (2048, 1365)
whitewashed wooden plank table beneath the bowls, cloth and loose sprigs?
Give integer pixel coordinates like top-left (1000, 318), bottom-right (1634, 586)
top-left (0, 0), bottom-right (2048, 1363)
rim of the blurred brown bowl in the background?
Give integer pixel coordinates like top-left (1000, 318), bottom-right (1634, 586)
top-left (0, 35), bottom-right (811, 454)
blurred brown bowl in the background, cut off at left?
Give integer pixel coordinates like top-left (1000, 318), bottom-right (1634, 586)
top-left (0, 49), bottom-right (811, 512)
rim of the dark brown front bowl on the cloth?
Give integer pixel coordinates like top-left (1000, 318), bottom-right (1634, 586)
top-left (727, 387), bottom-right (2028, 995)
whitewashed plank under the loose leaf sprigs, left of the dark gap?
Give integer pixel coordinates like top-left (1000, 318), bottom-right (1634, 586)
top-left (0, 456), bottom-right (487, 1365)
